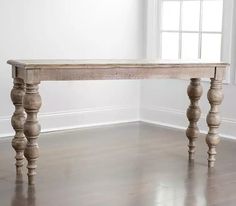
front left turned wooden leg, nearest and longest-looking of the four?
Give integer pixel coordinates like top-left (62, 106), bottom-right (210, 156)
top-left (24, 84), bottom-right (41, 185)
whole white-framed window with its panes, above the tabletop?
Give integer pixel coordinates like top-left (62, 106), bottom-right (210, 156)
top-left (147, 0), bottom-right (234, 62)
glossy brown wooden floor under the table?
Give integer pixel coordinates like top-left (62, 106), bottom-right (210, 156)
top-left (0, 123), bottom-right (236, 206)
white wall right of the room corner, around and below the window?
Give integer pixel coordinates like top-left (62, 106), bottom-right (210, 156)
top-left (140, 1), bottom-right (236, 138)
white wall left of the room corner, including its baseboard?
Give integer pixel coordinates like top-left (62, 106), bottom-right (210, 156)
top-left (0, 0), bottom-right (145, 136)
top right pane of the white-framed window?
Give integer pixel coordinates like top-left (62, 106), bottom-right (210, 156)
top-left (202, 0), bottom-right (223, 31)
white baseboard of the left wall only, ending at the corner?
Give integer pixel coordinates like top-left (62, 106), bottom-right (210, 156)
top-left (0, 106), bottom-right (140, 138)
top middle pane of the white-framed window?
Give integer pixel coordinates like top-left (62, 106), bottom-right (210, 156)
top-left (182, 1), bottom-right (200, 31)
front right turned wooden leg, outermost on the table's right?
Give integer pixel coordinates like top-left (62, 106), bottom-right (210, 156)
top-left (206, 79), bottom-right (224, 167)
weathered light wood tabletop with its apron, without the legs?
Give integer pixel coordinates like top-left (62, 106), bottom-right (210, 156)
top-left (8, 60), bottom-right (227, 83)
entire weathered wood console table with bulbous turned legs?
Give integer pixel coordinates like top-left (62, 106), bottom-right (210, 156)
top-left (8, 60), bottom-right (228, 184)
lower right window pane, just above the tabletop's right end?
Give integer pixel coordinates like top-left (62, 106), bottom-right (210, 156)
top-left (202, 34), bottom-right (221, 60)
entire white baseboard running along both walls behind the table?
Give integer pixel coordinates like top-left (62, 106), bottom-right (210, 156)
top-left (0, 106), bottom-right (236, 139)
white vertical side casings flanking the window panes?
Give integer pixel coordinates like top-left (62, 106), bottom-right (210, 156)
top-left (146, 0), bottom-right (234, 84)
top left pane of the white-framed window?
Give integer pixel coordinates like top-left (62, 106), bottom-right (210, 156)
top-left (162, 1), bottom-right (180, 30)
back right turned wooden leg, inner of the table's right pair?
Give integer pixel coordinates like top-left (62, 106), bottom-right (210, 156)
top-left (186, 79), bottom-right (203, 160)
